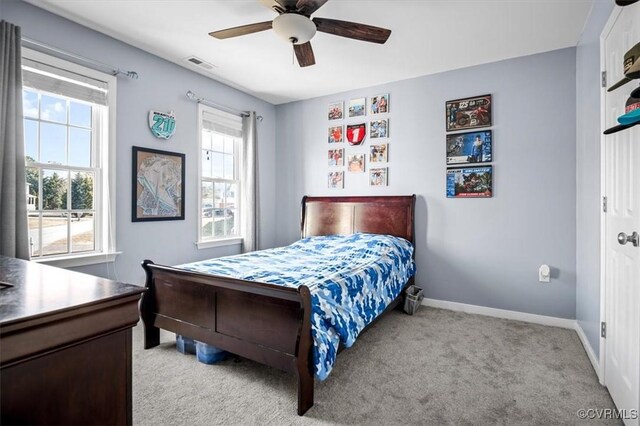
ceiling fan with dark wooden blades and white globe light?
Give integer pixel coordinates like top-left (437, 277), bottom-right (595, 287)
top-left (209, 0), bottom-right (391, 67)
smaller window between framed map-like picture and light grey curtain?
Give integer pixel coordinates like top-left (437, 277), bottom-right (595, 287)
top-left (198, 104), bottom-right (242, 248)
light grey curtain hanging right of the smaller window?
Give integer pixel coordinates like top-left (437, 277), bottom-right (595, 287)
top-left (242, 111), bottom-right (260, 253)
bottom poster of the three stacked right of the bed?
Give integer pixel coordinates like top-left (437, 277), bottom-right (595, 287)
top-left (447, 166), bottom-right (493, 198)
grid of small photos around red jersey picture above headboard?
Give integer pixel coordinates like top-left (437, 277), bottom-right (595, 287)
top-left (327, 93), bottom-right (389, 189)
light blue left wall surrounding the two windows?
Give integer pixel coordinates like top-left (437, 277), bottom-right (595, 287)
top-left (2, 0), bottom-right (275, 284)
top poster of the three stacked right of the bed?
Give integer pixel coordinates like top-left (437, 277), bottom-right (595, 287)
top-left (445, 95), bottom-right (491, 132)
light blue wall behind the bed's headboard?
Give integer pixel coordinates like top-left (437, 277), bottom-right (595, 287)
top-left (276, 48), bottom-right (576, 318)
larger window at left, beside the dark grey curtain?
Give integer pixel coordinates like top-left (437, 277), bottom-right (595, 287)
top-left (22, 49), bottom-right (115, 266)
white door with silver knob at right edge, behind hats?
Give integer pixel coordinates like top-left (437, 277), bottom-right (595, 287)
top-left (602, 3), bottom-right (640, 425)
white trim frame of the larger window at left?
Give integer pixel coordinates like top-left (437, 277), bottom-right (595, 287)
top-left (22, 48), bottom-right (121, 268)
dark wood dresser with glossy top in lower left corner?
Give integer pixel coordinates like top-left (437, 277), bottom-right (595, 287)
top-left (0, 256), bottom-right (144, 425)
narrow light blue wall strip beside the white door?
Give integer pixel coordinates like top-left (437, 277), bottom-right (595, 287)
top-left (576, 1), bottom-right (614, 357)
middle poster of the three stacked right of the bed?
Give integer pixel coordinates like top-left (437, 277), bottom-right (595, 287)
top-left (447, 130), bottom-right (493, 165)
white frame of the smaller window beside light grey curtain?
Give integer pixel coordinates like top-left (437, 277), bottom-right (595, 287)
top-left (196, 103), bottom-right (244, 249)
